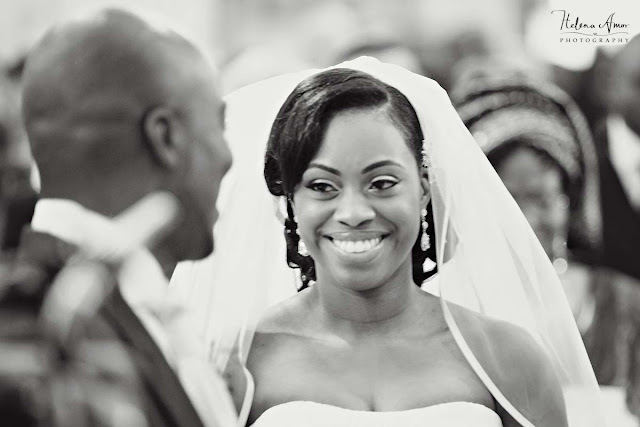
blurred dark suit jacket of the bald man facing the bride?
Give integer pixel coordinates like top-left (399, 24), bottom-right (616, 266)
top-left (0, 230), bottom-right (204, 426)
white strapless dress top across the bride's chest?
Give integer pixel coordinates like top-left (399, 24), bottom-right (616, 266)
top-left (252, 401), bottom-right (503, 427)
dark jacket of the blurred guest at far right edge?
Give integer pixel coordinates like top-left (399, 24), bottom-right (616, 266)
top-left (594, 121), bottom-right (640, 279)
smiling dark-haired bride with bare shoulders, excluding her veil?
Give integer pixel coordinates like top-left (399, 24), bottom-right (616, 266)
top-left (248, 68), bottom-right (566, 427)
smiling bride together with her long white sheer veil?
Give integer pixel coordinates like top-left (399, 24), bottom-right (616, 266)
top-left (170, 58), bottom-right (605, 427)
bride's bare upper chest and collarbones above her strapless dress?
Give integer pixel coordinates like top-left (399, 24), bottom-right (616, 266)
top-left (249, 297), bottom-right (494, 417)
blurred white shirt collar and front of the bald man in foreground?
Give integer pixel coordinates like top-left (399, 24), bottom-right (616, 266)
top-left (31, 199), bottom-right (238, 426)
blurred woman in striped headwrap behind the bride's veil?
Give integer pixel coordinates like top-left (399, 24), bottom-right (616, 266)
top-left (454, 74), bottom-right (640, 386)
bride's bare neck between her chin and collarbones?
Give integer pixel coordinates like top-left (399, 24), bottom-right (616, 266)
top-left (313, 268), bottom-right (422, 334)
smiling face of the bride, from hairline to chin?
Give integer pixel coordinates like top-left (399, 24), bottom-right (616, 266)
top-left (294, 110), bottom-right (429, 290)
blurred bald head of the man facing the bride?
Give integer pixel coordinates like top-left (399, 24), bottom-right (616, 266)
top-left (23, 10), bottom-right (231, 270)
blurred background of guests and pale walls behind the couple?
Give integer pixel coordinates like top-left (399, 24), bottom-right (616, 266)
top-left (0, 0), bottom-right (640, 426)
